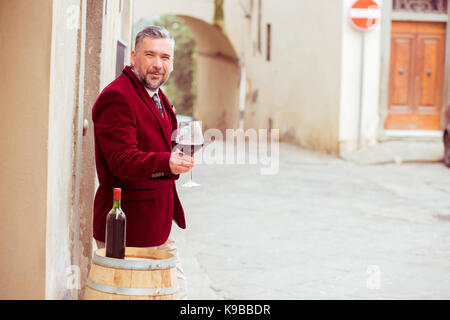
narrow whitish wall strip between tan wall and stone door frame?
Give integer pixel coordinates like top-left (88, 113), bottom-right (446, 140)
top-left (46, 0), bottom-right (82, 299)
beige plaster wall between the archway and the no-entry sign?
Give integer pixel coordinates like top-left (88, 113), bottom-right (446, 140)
top-left (243, 0), bottom-right (342, 152)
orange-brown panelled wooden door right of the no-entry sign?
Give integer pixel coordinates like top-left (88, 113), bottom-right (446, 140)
top-left (385, 21), bottom-right (446, 130)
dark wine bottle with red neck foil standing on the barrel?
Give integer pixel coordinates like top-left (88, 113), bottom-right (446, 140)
top-left (106, 188), bottom-right (127, 259)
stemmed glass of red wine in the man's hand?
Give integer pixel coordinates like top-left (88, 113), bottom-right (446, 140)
top-left (176, 121), bottom-right (204, 188)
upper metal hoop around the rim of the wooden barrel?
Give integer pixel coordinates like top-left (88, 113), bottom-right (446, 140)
top-left (92, 254), bottom-right (176, 270)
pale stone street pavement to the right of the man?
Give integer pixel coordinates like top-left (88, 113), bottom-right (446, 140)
top-left (175, 144), bottom-right (450, 299)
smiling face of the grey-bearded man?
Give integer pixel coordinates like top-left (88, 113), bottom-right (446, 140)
top-left (131, 37), bottom-right (173, 91)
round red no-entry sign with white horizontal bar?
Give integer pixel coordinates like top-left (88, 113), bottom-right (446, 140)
top-left (350, 0), bottom-right (381, 30)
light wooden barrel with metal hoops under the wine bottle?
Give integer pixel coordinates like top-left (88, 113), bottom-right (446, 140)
top-left (84, 247), bottom-right (178, 300)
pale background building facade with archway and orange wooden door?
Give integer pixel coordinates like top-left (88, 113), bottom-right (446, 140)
top-left (134, 0), bottom-right (449, 153)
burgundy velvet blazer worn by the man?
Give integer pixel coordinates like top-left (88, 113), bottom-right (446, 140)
top-left (92, 66), bottom-right (186, 247)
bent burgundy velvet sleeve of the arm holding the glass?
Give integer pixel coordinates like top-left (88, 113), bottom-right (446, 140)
top-left (92, 93), bottom-right (177, 180)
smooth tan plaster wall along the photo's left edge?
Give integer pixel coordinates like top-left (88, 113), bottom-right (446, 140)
top-left (0, 0), bottom-right (53, 299)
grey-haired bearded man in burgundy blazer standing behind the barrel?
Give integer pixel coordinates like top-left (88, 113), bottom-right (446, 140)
top-left (92, 26), bottom-right (194, 298)
